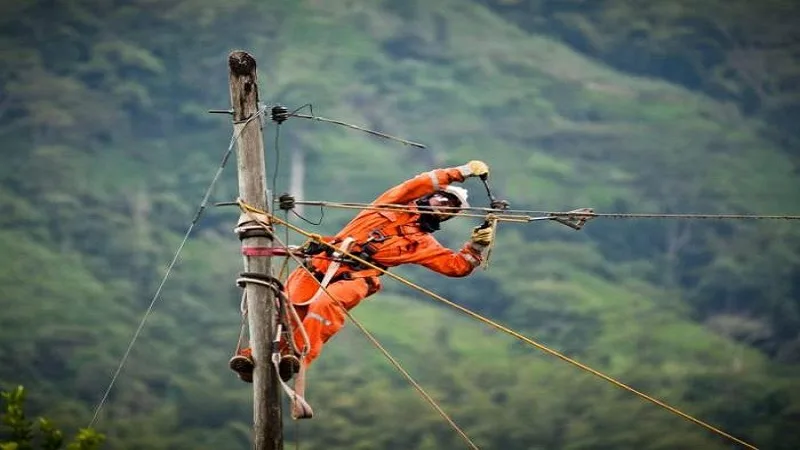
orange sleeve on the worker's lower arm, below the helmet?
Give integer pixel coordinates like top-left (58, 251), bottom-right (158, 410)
top-left (400, 234), bottom-right (482, 277)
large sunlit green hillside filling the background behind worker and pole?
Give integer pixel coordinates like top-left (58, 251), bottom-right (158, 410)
top-left (0, 0), bottom-right (800, 449)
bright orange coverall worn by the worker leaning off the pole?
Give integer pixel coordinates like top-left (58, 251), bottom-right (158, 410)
top-left (286, 168), bottom-right (481, 365)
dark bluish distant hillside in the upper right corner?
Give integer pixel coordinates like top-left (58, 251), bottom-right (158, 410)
top-left (480, 0), bottom-right (800, 151)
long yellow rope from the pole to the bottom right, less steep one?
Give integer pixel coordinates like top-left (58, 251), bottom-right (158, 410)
top-left (238, 199), bottom-right (758, 450)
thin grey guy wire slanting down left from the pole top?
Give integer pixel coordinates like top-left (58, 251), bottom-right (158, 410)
top-left (89, 109), bottom-right (264, 427)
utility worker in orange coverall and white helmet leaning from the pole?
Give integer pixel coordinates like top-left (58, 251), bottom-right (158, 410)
top-left (230, 161), bottom-right (494, 382)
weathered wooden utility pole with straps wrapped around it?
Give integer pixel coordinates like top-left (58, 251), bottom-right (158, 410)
top-left (228, 51), bottom-right (283, 450)
